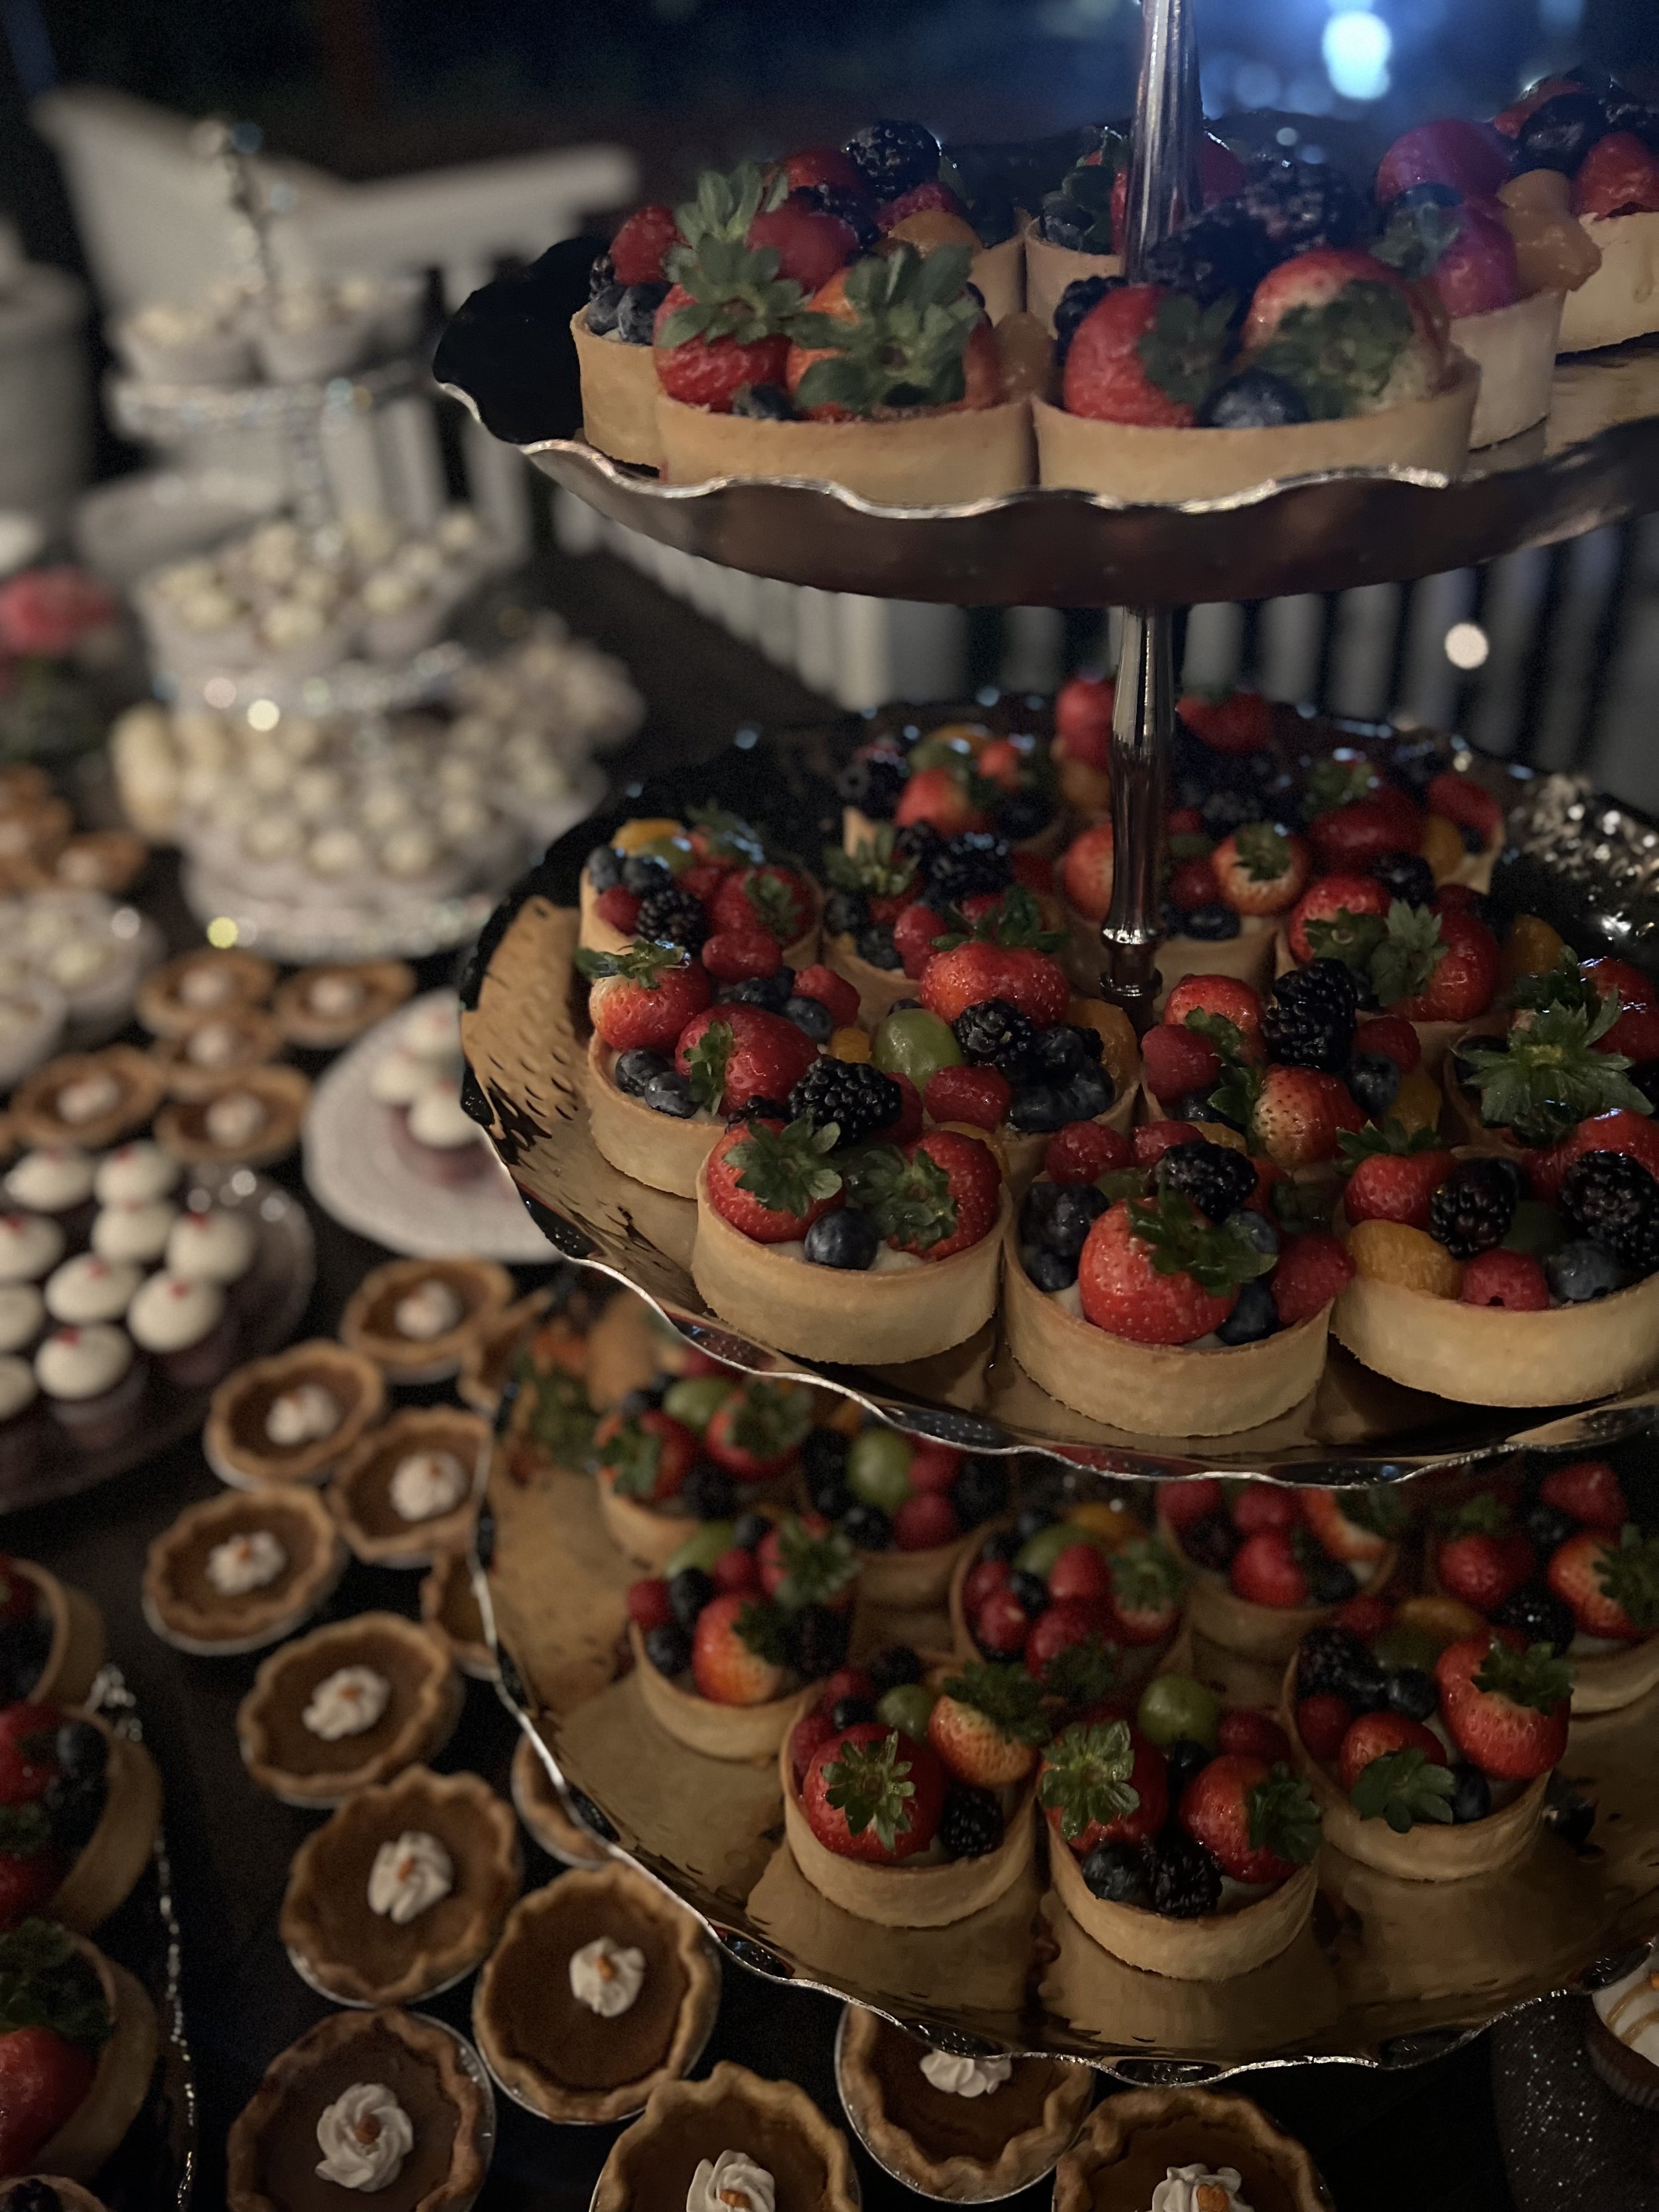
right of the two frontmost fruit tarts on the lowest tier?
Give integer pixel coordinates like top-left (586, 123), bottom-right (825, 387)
top-left (1037, 1674), bottom-right (1321, 1982)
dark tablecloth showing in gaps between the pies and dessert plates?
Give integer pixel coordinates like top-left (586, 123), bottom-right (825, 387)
top-left (0, 540), bottom-right (1530, 2212)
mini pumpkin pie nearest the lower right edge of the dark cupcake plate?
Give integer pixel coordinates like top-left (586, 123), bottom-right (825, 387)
top-left (201, 1336), bottom-right (385, 1489)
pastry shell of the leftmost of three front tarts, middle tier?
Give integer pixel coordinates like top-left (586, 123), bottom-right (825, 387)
top-left (692, 1165), bottom-right (1013, 1367)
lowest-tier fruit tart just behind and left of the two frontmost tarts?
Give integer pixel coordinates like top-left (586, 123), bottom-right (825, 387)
top-left (628, 1513), bottom-right (858, 1761)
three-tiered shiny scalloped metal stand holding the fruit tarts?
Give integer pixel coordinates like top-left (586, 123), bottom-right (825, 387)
top-left (438, 0), bottom-right (1659, 2079)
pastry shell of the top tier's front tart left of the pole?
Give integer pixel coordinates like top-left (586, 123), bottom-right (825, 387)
top-left (657, 396), bottom-right (1031, 506)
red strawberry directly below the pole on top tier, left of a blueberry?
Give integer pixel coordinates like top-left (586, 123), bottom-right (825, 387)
top-left (1062, 283), bottom-right (1228, 429)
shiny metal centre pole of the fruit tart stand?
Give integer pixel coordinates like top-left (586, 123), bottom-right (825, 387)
top-left (1100, 0), bottom-right (1201, 1031)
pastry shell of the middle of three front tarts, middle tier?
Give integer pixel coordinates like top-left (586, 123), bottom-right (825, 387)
top-left (1002, 1223), bottom-right (1332, 1436)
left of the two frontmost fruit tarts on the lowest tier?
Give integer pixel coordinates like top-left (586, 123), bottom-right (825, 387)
top-left (778, 1653), bottom-right (1048, 1929)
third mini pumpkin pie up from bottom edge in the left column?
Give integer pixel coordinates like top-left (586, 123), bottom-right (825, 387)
top-left (237, 1613), bottom-right (460, 1807)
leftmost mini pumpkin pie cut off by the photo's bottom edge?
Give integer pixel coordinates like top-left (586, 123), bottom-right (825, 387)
top-left (226, 2006), bottom-right (489, 2212)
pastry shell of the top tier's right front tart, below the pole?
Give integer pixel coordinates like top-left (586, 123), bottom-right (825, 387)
top-left (1031, 356), bottom-right (1480, 506)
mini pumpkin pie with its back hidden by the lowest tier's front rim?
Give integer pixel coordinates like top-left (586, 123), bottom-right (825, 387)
top-left (836, 2004), bottom-right (1095, 2203)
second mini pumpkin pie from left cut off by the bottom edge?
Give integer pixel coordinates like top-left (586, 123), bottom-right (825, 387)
top-left (591, 2061), bottom-right (861, 2212)
